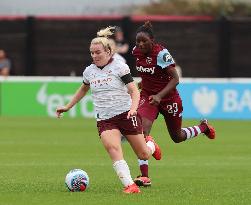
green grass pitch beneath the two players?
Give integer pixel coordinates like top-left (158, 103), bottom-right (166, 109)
top-left (0, 117), bottom-right (251, 205)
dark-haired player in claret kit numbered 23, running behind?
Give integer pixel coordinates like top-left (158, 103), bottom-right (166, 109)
top-left (132, 21), bottom-right (215, 186)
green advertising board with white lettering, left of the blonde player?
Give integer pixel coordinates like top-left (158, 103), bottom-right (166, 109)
top-left (0, 79), bottom-right (94, 118)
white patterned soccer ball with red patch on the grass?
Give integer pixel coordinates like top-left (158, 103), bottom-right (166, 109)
top-left (65, 169), bottom-right (89, 192)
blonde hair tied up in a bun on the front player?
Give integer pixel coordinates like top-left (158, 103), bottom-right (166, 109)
top-left (91, 26), bottom-right (116, 55)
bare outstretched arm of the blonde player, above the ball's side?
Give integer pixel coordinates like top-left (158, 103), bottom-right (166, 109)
top-left (56, 83), bottom-right (90, 118)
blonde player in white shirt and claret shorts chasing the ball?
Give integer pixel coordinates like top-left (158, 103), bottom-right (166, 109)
top-left (56, 27), bottom-right (161, 193)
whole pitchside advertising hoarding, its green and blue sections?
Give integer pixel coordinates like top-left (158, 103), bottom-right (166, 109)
top-left (0, 76), bottom-right (251, 119)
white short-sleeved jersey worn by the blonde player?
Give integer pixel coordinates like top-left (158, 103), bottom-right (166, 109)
top-left (83, 59), bottom-right (131, 121)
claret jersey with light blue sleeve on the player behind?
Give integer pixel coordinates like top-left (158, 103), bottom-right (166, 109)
top-left (132, 44), bottom-right (178, 98)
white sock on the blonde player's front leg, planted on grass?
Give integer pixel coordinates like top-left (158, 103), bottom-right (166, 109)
top-left (113, 160), bottom-right (134, 187)
